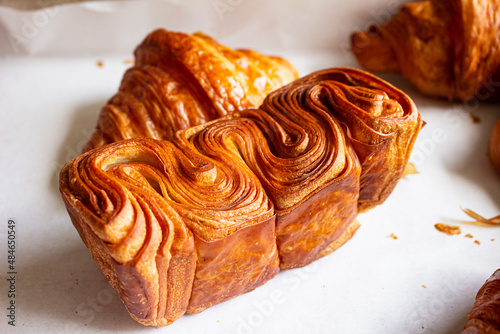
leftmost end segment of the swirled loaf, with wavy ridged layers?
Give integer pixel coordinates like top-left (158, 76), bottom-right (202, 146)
top-left (60, 147), bottom-right (196, 326)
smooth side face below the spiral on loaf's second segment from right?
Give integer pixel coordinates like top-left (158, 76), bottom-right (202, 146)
top-left (276, 171), bottom-right (360, 269)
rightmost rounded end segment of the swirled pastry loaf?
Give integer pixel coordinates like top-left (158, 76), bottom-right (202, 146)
top-left (282, 68), bottom-right (423, 212)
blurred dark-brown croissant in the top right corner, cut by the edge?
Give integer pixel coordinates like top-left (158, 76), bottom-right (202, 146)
top-left (351, 0), bottom-right (500, 100)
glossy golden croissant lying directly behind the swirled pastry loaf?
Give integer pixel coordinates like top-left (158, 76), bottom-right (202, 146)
top-left (83, 29), bottom-right (298, 152)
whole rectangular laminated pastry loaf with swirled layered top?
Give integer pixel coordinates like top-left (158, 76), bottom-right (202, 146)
top-left (60, 68), bottom-right (422, 326)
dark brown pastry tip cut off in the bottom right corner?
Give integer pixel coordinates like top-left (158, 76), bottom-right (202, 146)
top-left (462, 269), bottom-right (500, 334)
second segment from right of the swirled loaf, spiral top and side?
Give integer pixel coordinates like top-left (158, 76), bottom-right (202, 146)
top-left (177, 108), bottom-right (360, 269)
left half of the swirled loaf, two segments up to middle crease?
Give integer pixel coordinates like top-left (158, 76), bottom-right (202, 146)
top-left (60, 139), bottom-right (279, 326)
